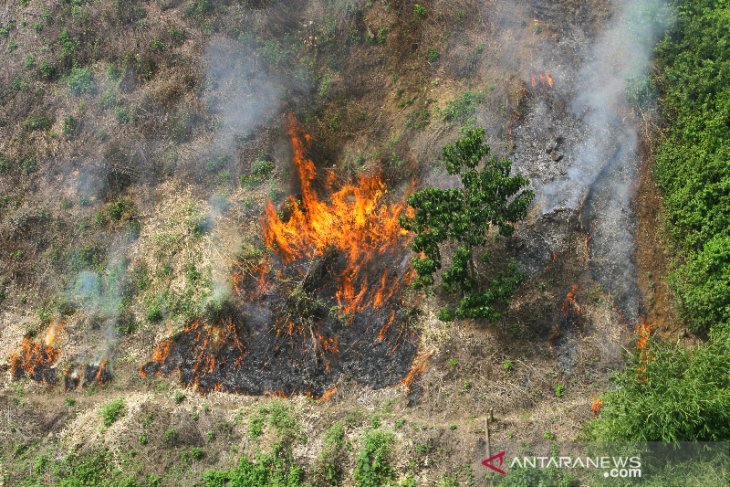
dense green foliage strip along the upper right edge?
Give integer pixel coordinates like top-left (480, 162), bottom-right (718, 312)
top-left (655, 0), bottom-right (730, 331)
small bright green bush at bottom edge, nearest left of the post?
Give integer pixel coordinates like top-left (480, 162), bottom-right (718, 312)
top-left (353, 430), bottom-right (395, 487)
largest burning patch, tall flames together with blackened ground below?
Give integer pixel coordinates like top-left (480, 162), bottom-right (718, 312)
top-left (141, 115), bottom-right (416, 397)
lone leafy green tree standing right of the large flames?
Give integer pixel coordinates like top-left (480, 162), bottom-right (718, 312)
top-left (400, 128), bottom-right (534, 321)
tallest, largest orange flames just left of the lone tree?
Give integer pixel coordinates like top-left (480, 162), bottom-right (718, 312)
top-left (264, 115), bottom-right (407, 314)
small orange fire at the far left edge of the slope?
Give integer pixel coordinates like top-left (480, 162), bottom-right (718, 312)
top-left (8, 322), bottom-right (62, 384)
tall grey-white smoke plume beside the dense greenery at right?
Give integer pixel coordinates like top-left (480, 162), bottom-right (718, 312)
top-left (543, 0), bottom-right (671, 325)
